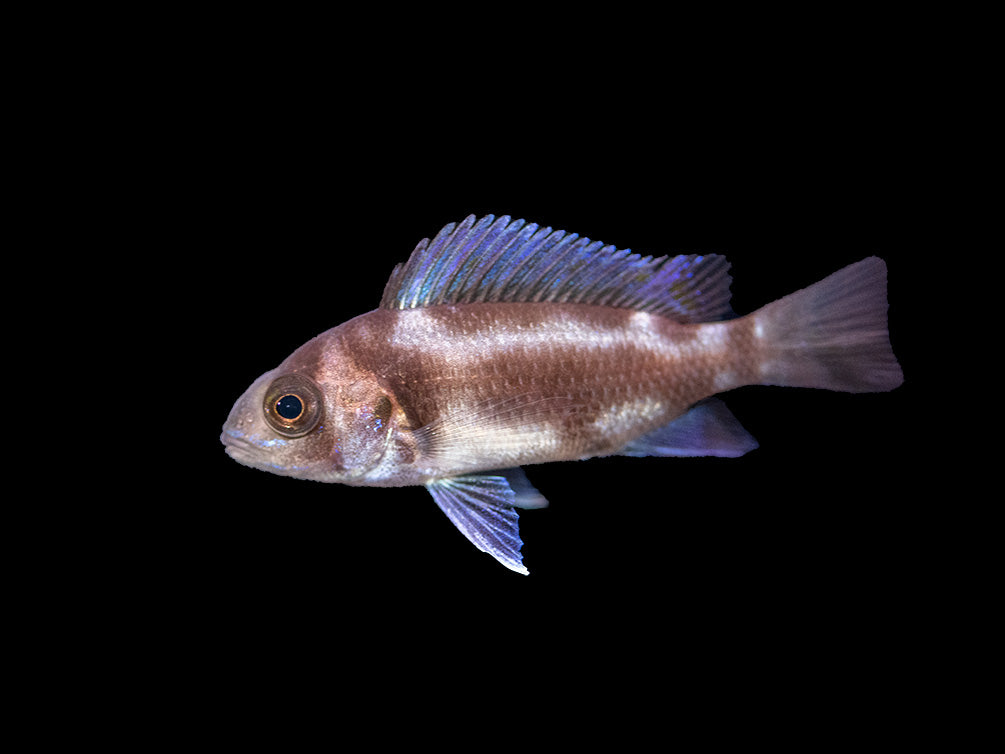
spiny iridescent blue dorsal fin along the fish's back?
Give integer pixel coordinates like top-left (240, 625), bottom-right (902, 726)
top-left (380, 215), bottom-right (732, 323)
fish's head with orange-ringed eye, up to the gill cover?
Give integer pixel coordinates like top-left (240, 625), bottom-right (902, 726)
top-left (220, 329), bottom-right (400, 484)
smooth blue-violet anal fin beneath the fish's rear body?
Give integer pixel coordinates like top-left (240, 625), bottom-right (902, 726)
top-left (621, 398), bottom-right (758, 458)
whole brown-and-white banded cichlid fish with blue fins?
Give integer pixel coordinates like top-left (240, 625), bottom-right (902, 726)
top-left (221, 215), bottom-right (903, 574)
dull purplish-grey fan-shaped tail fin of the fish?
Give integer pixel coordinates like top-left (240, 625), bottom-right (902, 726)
top-left (750, 256), bottom-right (903, 393)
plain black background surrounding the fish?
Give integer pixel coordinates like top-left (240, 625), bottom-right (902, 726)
top-left (21, 4), bottom-right (980, 751)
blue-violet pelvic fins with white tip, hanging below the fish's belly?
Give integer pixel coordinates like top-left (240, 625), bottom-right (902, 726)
top-left (426, 468), bottom-right (548, 575)
